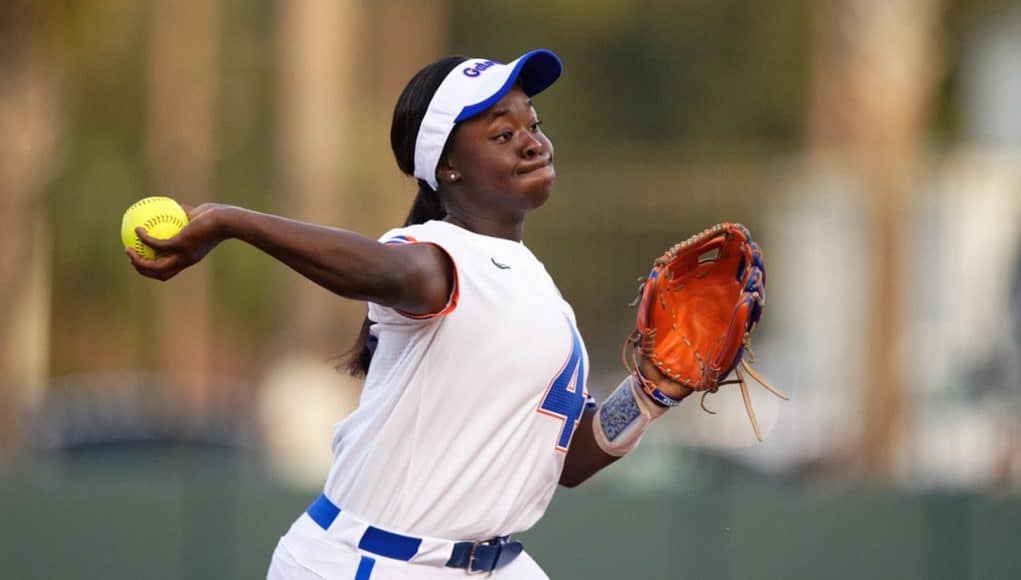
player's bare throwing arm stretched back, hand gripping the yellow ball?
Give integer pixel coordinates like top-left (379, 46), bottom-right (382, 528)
top-left (128, 204), bottom-right (453, 315)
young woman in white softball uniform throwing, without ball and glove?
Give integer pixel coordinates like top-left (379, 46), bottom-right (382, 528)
top-left (123, 50), bottom-right (689, 580)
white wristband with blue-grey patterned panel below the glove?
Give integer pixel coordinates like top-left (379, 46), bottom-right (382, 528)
top-left (592, 375), bottom-right (667, 457)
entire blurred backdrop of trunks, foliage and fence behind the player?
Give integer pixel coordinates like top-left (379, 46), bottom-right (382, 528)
top-left (0, 0), bottom-right (1021, 580)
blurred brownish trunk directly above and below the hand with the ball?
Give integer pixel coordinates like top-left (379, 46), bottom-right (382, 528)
top-left (147, 0), bottom-right (221, 416)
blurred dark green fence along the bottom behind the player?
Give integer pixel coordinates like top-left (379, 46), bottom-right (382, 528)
top-left (0, 454), bottom-right (1021, 580)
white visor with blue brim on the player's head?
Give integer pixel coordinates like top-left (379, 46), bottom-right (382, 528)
top-left (415, 49), bottom-right (561, 190)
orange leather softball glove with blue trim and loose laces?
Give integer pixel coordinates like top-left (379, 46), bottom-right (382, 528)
top-left (625, 224), bottom-right (787, 441)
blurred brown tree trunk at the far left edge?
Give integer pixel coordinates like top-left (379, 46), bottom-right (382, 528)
top-left (0, 1), bottom-right (65, 455)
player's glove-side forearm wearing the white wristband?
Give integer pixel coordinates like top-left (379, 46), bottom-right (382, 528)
top-left (560, 359), bottom-right (692, 487)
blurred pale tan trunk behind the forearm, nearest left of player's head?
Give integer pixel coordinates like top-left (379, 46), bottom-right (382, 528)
top-left (276, 0), bottom-right (370, 359)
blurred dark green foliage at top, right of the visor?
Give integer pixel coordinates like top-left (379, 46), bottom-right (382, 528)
top-left (452, 0), bottom-right (812, 152)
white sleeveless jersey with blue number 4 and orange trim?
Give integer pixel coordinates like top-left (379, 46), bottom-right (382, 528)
top-left (325, 221), bottom-right (594, 539)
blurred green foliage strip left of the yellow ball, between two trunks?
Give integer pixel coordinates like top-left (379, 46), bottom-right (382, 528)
top-left (36, 0), bottom-right (149, 376)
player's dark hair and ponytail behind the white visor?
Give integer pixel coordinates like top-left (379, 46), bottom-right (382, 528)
top-left (339, 56), bottom-right (468, 377)
